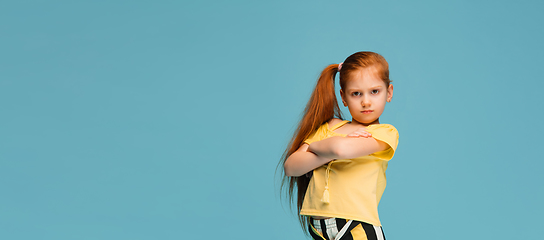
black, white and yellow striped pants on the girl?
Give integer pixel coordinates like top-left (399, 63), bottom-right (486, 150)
top-left (309, 218), bottom-right (385, 240)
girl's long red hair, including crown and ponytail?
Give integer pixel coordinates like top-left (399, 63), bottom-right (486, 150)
top-left (278, 52), bottom-right (391, 231)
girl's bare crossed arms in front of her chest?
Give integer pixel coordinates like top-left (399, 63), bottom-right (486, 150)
top-left (284, 131), bottom-right (389, 177)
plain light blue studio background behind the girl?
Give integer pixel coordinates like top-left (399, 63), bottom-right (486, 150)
top-left (0, 0), bottom-right (544, 240)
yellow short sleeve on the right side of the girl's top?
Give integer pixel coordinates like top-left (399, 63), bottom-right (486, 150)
top-left (367, 124), bottom-right (399, 161)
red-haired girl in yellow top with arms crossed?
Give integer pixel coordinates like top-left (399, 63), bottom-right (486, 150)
top-left (280, 52), bottom-right (398, 240)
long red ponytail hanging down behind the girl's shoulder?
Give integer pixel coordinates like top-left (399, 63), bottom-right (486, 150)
top-left (278, 64), bottom-right (343, 229)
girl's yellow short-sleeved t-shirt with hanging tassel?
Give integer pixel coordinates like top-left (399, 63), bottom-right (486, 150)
top-left (300, 121), bottom-right (399, 226)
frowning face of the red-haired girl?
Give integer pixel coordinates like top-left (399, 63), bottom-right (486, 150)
top-left (340, 67), bottom-right (393, 126)
